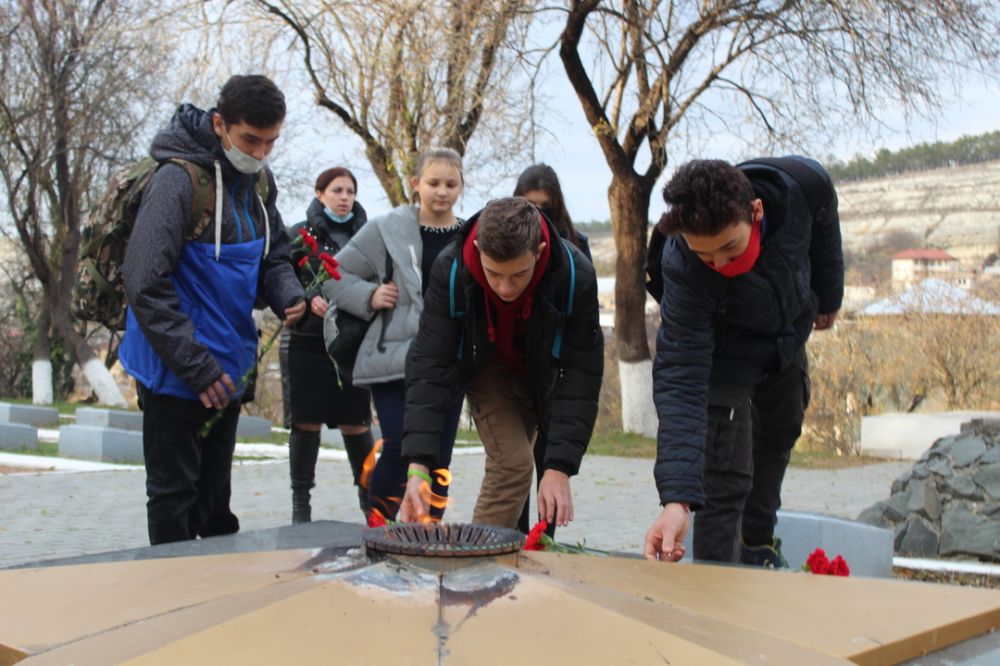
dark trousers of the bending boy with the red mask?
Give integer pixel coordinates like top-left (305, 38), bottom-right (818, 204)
top-left (693, 347), bottom-right (809, 562)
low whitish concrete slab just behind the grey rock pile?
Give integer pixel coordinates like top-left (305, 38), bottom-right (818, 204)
top-left (861, 410), bottom-right (1000, 460)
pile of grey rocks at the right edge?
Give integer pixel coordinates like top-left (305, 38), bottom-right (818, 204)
top-left (858, 419), bottom-right (1000, 562)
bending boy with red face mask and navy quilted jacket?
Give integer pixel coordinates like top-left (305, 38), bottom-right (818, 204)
top-left (644, 158), bottom-right (844, 567)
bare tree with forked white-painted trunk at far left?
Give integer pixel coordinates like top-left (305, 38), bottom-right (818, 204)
top-left (0, 0), bottom-right (169, 405)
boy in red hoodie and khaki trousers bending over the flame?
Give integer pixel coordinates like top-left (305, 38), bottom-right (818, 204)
top-left (400, 197), bottom-right (604, 527)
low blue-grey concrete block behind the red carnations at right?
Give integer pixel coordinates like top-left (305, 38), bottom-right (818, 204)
top-left (684, 511), bottom-right (893, 578)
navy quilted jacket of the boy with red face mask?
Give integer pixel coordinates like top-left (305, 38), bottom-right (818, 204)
top-left (653, 161), bottom-right (844, 509)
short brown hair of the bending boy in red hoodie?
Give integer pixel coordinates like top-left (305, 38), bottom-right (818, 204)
top-left (476, 197), bottom-right (542, 261)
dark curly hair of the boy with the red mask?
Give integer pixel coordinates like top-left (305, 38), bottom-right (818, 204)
top-left (658, 160), bottom-right (756, 236)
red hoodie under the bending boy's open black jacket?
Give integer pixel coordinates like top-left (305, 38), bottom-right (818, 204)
top-left (462, 216), bottom-right (551, 375)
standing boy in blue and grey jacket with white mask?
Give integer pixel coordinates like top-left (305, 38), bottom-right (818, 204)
top-left (119, 75), bottom-right (305, 544)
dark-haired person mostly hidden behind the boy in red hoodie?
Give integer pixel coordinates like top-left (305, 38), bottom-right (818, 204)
top-left (514, 164), bottom-right (594, 537)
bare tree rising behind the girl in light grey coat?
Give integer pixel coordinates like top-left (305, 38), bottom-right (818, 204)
top-left (244, 0), bottom-right (533, 205)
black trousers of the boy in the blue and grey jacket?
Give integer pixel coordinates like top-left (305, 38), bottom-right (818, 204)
top-left (138, 384), bottom-right (240, 545)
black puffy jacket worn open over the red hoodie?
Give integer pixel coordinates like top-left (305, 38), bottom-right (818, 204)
top-left (403, 214), bottom-right (604, 475)
